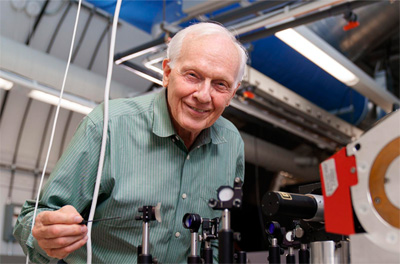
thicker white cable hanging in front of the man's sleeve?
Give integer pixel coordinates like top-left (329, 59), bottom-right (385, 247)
top-left (86, 0), bottom-right (122, 264)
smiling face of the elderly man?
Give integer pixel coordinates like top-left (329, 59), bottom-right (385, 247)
top-left (163, 35), bottom-right (239, 136)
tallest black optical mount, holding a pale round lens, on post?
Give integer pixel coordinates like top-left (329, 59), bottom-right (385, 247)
top-left (208, 177), bottom-right (243, 263)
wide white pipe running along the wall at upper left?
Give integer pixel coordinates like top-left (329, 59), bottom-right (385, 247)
top-left (0, 36), bottom-right (133, 102)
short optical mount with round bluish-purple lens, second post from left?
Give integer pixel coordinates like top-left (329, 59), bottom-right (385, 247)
top-left (182, 213), bottom-right (203, 264)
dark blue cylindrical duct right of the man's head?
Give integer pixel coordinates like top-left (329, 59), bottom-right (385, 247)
top-left (250, 36), bottom-right (368, 124)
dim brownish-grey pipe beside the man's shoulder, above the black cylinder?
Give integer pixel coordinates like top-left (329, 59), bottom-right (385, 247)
top-left (240, 132), bottom-right (319, 182)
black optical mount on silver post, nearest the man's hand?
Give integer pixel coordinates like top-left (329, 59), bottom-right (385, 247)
top-left (135, 205), bottom-right (157, 264)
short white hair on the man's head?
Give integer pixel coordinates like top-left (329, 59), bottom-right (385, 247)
top-left (167, 22), bottom-right (247, 86)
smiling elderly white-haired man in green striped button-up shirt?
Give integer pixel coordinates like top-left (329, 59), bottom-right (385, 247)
top-left (14, 23), bottom-right (247, 263)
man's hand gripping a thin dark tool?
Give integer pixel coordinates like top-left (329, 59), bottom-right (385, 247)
top-left (32, 205), bottom-right (87, 259)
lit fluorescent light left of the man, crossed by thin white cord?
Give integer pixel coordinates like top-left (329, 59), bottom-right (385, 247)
top-left (29, 90), bottom-right (93, 115)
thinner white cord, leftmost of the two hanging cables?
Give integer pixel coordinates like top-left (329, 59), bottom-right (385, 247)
top-left (26, 0), bottom-right (82, 264)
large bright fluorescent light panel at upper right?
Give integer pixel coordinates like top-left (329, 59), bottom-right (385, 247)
top-left (275, 28), bottom-right (359, 86)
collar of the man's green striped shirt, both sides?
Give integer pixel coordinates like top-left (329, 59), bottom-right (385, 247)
top-left (153, 89), bottom-right (227, 145)
